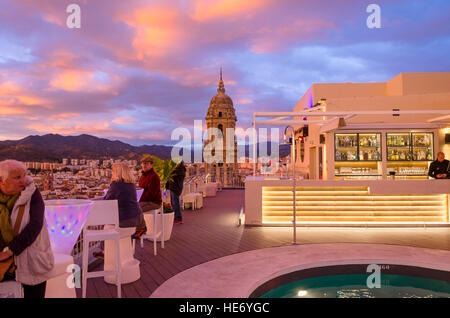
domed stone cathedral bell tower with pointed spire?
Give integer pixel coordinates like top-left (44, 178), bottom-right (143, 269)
top-left (204, 68), bottom-right (238, 186)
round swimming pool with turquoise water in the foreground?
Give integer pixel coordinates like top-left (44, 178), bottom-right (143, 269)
top-left (250, 264), bottom-right (450, 298)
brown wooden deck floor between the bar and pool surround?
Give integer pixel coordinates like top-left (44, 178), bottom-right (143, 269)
top-left (77, 189), bottom-right (450, 298)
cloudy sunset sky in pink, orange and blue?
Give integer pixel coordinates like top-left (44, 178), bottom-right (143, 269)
top-left (0, 0), bottom-right (450, 145)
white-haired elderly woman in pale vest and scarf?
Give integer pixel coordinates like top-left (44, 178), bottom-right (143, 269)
top-left (0, 160), bottom-right (54, 298)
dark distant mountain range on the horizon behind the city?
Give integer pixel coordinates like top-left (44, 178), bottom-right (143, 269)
top-left (0, 134), bottom-right (289, 162)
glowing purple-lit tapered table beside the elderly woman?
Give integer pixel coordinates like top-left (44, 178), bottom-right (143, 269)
top-left (45, 200), bottom-right (94, 255)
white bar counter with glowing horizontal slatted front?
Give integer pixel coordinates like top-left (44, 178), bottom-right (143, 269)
top-left (245, 176), bottom-right (450, 226)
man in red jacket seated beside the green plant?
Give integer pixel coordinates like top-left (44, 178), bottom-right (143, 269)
top-left (132, 156), bottom-right (162, 239)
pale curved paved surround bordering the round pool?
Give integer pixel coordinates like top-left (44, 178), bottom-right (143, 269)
top-left (150, 243), bottom-right (450, 298)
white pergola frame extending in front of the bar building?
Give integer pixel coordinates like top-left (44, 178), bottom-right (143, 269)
top-left (252, 106), bottom-right (450, 176)
